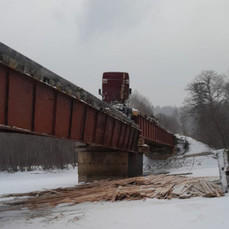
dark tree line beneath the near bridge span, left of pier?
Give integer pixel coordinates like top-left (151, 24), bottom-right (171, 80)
top-left (0, 133), bottom-right (77, 172)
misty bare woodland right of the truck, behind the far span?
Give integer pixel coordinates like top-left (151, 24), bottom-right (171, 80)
top-left (130, 71), bottom-right (229, 149)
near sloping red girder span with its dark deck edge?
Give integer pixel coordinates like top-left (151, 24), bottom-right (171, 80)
top-left (0, 43), bottom-right (140, 152)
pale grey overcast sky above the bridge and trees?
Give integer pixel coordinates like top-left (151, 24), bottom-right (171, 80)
top-left (0, 0), bottom-right (229, 106)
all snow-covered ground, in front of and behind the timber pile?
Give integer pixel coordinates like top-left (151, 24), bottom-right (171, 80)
top-left (0, 135), bottom-right (229, 229)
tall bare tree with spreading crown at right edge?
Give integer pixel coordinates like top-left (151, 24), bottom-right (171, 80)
top-left (185, 71), bottom-right (228, 147)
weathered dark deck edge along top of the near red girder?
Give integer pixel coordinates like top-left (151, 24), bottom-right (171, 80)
top-left (0, 42), bottom-right (136, 123)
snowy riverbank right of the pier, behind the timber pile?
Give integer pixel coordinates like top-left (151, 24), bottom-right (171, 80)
top-left (143, 136), bottom-right (221, 177)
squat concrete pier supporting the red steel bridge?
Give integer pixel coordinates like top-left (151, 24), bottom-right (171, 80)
top-left (77, 146), bottom-right (143, 182)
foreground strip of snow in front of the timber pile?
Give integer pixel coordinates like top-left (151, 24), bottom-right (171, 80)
top-left (0, 195), bottom-right (229, 229)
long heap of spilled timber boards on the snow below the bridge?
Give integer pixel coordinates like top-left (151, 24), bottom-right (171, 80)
top-left (4, 174), bottom-right (223, 209)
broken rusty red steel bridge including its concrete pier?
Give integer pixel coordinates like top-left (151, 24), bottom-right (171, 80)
top-left (0, 43), bottom-right (175, 181)
